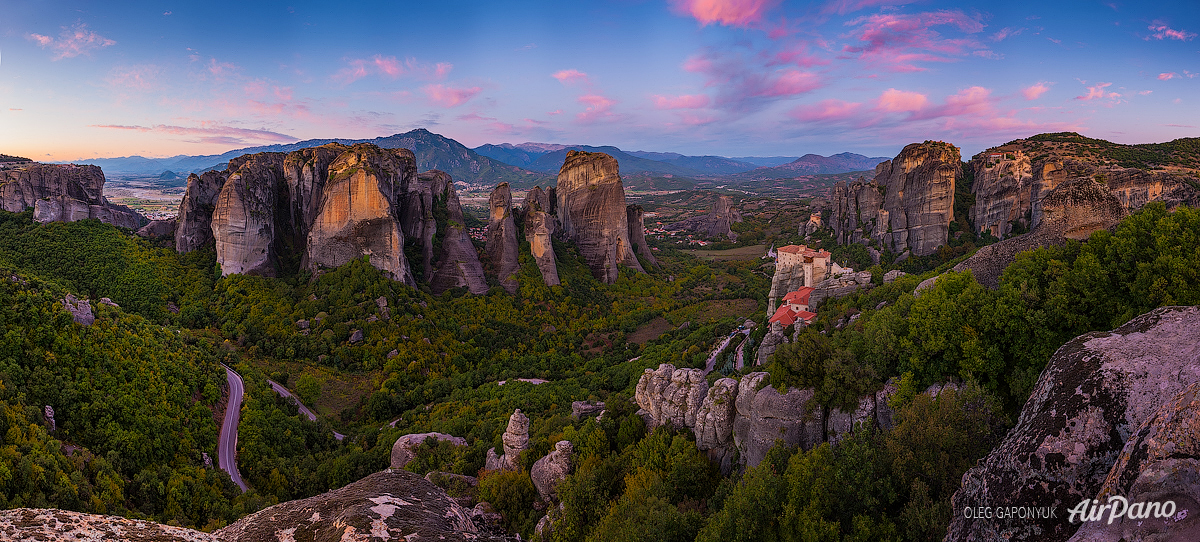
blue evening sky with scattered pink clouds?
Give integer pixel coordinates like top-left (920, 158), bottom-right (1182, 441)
top-left (0, 0), bottom-right (1200, 161)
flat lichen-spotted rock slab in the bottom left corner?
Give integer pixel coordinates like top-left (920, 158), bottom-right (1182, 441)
top-left (0, 508), bottom-right (213, 542)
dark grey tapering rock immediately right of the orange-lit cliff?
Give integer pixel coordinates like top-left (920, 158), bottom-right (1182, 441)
top-left (412, 169), bottom-right (487, 295)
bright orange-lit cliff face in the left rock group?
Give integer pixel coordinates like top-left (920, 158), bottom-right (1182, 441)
top-left (307, 143), bottom-right (416, 285)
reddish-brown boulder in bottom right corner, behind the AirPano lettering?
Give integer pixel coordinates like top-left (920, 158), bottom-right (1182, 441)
top-left (1070, 384), bottom-right (1200, 542)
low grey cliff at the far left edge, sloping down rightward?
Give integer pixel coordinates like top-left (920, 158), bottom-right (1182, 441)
top-left (0, 162), bottom-right (146, 229)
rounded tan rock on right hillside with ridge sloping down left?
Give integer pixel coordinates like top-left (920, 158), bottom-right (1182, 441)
top-left (954, 177), bottom-right (1127, 289)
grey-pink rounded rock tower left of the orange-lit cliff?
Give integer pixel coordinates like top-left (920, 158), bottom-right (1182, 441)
top-left (211, 152), bottom-right (284, 277)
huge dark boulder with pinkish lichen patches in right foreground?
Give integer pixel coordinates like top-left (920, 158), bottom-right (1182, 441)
top-left (946, 307), bottom-right (1200, 541)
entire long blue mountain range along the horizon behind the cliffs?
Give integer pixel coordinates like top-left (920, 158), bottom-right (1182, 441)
top-left (70, 128), bottom-right (887, 188)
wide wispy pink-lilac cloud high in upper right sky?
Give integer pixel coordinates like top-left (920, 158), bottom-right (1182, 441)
top-left (842, 10), bottom-right (986, 72)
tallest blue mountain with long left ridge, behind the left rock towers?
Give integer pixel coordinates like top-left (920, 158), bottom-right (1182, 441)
top-left (70, 128), bottom-right (549, 187)
